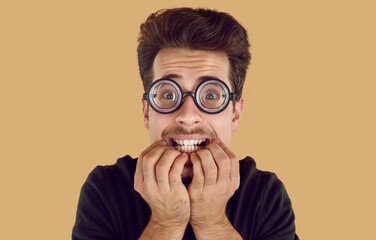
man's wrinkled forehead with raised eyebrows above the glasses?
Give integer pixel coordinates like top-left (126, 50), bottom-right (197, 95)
top-left (153, 48), bottom-right (230, 86)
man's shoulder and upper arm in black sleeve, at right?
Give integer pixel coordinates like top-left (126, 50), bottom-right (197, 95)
top-left (236, 157), bottom-right (295, 239)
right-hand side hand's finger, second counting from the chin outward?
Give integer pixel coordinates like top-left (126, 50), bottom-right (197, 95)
top-left (196, 148), bottom-right (218, 189)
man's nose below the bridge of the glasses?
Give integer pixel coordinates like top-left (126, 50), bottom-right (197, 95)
top-left (176, 96), bottom-right (202, 127)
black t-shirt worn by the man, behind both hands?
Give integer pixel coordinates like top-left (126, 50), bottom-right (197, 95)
top-left (72, 155), bottom-right (299, 240)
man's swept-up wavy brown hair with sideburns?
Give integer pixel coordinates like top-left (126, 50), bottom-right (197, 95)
top-left (137, 8), bottom-right (251, 100)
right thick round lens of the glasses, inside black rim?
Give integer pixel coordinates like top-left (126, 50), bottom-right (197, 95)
top-left (198, 81), bottom-right (228, 112)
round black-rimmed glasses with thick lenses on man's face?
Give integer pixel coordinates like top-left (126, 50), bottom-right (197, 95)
top-left (143, 78), bottom-right (236, 114)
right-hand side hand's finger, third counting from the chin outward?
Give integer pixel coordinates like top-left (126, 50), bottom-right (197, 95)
top-left (206, 142), bottom-right (231, 183)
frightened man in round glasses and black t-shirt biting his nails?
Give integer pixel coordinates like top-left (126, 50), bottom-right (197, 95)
top-left (73, 8), bottom-right (298, 240)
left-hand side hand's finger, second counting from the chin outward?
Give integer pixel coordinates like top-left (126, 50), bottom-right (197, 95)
top-left (155, 149), bottom-right (181, 192)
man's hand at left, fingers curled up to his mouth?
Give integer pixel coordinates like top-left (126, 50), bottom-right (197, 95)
top-left (134, 141), bottom-right (190, 234)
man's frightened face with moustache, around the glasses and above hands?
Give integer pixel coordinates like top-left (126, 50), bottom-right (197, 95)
top-left (143, 48), bottom-right (243, 177)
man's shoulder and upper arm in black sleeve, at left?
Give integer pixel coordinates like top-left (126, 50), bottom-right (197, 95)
top-left (72, 156), bottom-right (148, 239)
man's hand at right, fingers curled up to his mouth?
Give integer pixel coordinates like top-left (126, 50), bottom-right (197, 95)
top-left (188, 140), bottom-right (240, 236)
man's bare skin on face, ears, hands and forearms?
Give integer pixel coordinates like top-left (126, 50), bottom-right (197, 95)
top-left (134, 48), bottom-right (244, 239)
